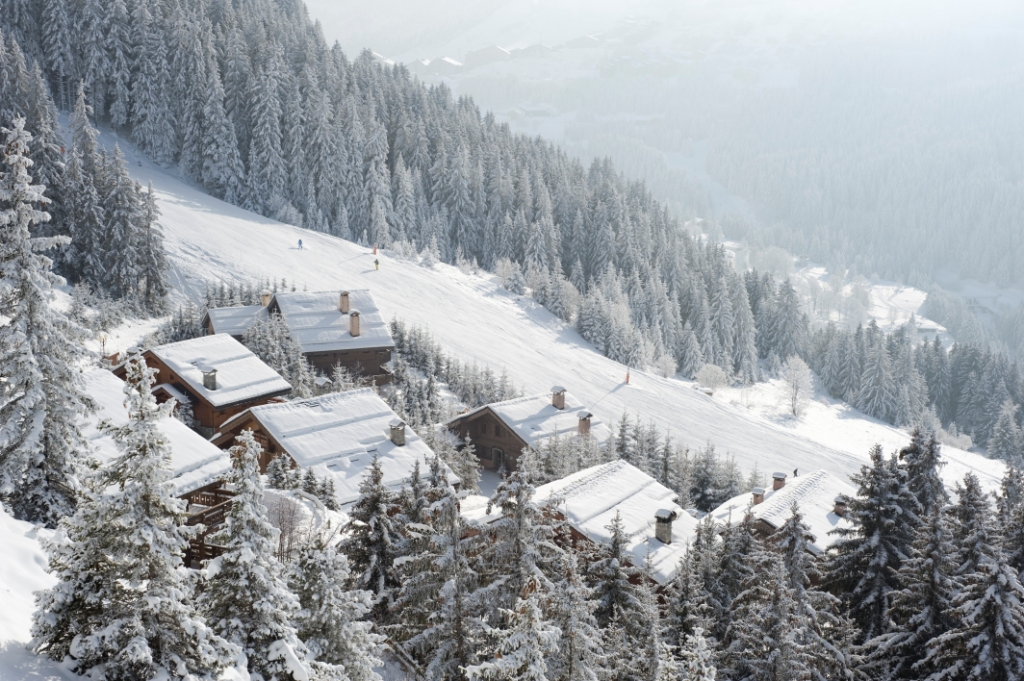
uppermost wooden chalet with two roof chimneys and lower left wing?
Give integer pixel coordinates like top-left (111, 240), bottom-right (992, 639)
top-left (203, 290), bottom-right (394, 385)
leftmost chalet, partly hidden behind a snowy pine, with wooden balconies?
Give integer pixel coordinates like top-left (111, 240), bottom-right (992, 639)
top-left (82, 369), bottom-right (234, 567)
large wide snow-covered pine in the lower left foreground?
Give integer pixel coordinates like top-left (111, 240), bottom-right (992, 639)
top-left (32, 354), bottom-right (238, 680)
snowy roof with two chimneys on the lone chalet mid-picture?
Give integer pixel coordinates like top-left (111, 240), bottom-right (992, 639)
top-left (449, 386), bottom-right (611, 449)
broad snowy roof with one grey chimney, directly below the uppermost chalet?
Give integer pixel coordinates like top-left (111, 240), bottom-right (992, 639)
top-left (221, 388), bottom-right (450, 504)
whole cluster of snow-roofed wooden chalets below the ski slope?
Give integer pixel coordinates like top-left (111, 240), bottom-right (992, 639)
top-left (96, 282), bottom-right (856, 573)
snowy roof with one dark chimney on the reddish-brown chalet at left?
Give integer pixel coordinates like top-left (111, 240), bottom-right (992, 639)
top-left (151, 334), bottom-right (292, 409)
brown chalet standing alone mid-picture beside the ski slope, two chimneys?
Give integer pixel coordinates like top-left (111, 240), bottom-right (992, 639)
top-left (446, 386), bottom-right (611, 470)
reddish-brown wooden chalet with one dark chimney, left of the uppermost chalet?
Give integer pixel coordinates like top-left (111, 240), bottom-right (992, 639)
top-left (114, 334), bottom-right (292, 437)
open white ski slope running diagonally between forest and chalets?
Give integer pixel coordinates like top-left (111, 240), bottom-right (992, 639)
top-left (100, 127), bottom-right (1004, 488)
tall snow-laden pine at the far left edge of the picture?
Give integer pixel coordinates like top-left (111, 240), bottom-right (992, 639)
top-left (0, 119), bottom-right (92, 526)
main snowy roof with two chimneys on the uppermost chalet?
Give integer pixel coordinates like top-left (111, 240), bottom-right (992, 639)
top-left (270, 289), bottom-right (394, 352)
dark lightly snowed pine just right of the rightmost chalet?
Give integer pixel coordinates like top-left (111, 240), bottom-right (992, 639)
top-left (825, 445), bottom-right (921, 639)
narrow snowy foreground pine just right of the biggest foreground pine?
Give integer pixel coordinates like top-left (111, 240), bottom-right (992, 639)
top-left (200, 430), bottom-right (311, 681)
